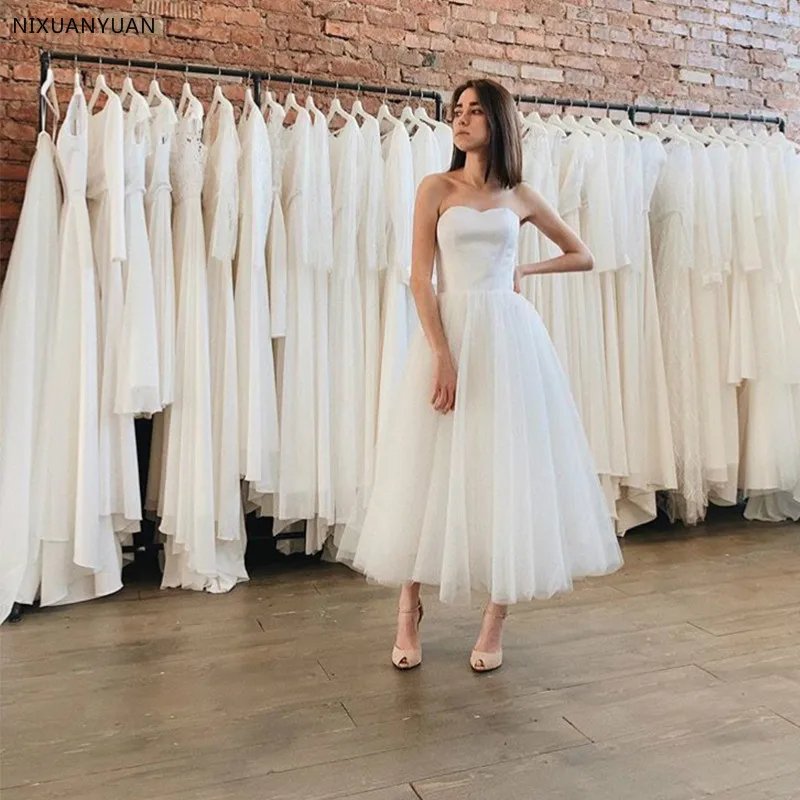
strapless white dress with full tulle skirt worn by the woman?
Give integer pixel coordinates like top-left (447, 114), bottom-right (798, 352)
top-left (336, 206), bottom-right (622, 604)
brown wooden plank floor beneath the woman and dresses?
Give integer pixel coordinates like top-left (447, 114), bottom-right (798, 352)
top-left (0, 517), bottom-right (800, 800)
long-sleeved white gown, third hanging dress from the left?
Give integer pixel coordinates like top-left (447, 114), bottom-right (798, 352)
top-left (86, 84), bottom-right (142, 534)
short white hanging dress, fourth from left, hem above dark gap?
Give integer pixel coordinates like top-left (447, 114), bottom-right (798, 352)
top-left (114, 92), bottom-right (162, 417)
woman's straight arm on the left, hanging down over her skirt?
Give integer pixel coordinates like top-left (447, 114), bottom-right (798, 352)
top-left (411, 175), bottom-right (456, 414)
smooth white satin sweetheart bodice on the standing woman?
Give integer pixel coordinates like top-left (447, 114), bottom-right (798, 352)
top-left (436, 206), bottom-right (519, 294)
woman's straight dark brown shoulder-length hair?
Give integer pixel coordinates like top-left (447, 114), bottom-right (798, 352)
top-left (450, 78), bottom-right (522, 189)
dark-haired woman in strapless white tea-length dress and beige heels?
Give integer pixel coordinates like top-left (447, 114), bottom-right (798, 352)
top-left (337, 80), bottom-right (622, 672)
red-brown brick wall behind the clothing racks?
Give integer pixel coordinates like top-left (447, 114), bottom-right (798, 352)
top-left (0, 0), bottom-right (800, 278)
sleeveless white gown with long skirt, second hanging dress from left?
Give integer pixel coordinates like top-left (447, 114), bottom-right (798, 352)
top-left (27, 88), bottom-right (122, 606)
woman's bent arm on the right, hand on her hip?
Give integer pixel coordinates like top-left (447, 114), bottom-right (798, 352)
top-left (516, 183), bottom-right (594, 278)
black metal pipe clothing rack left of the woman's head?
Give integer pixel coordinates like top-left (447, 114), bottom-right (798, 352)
top-left (39, 50), bottom-right (444, 130)
